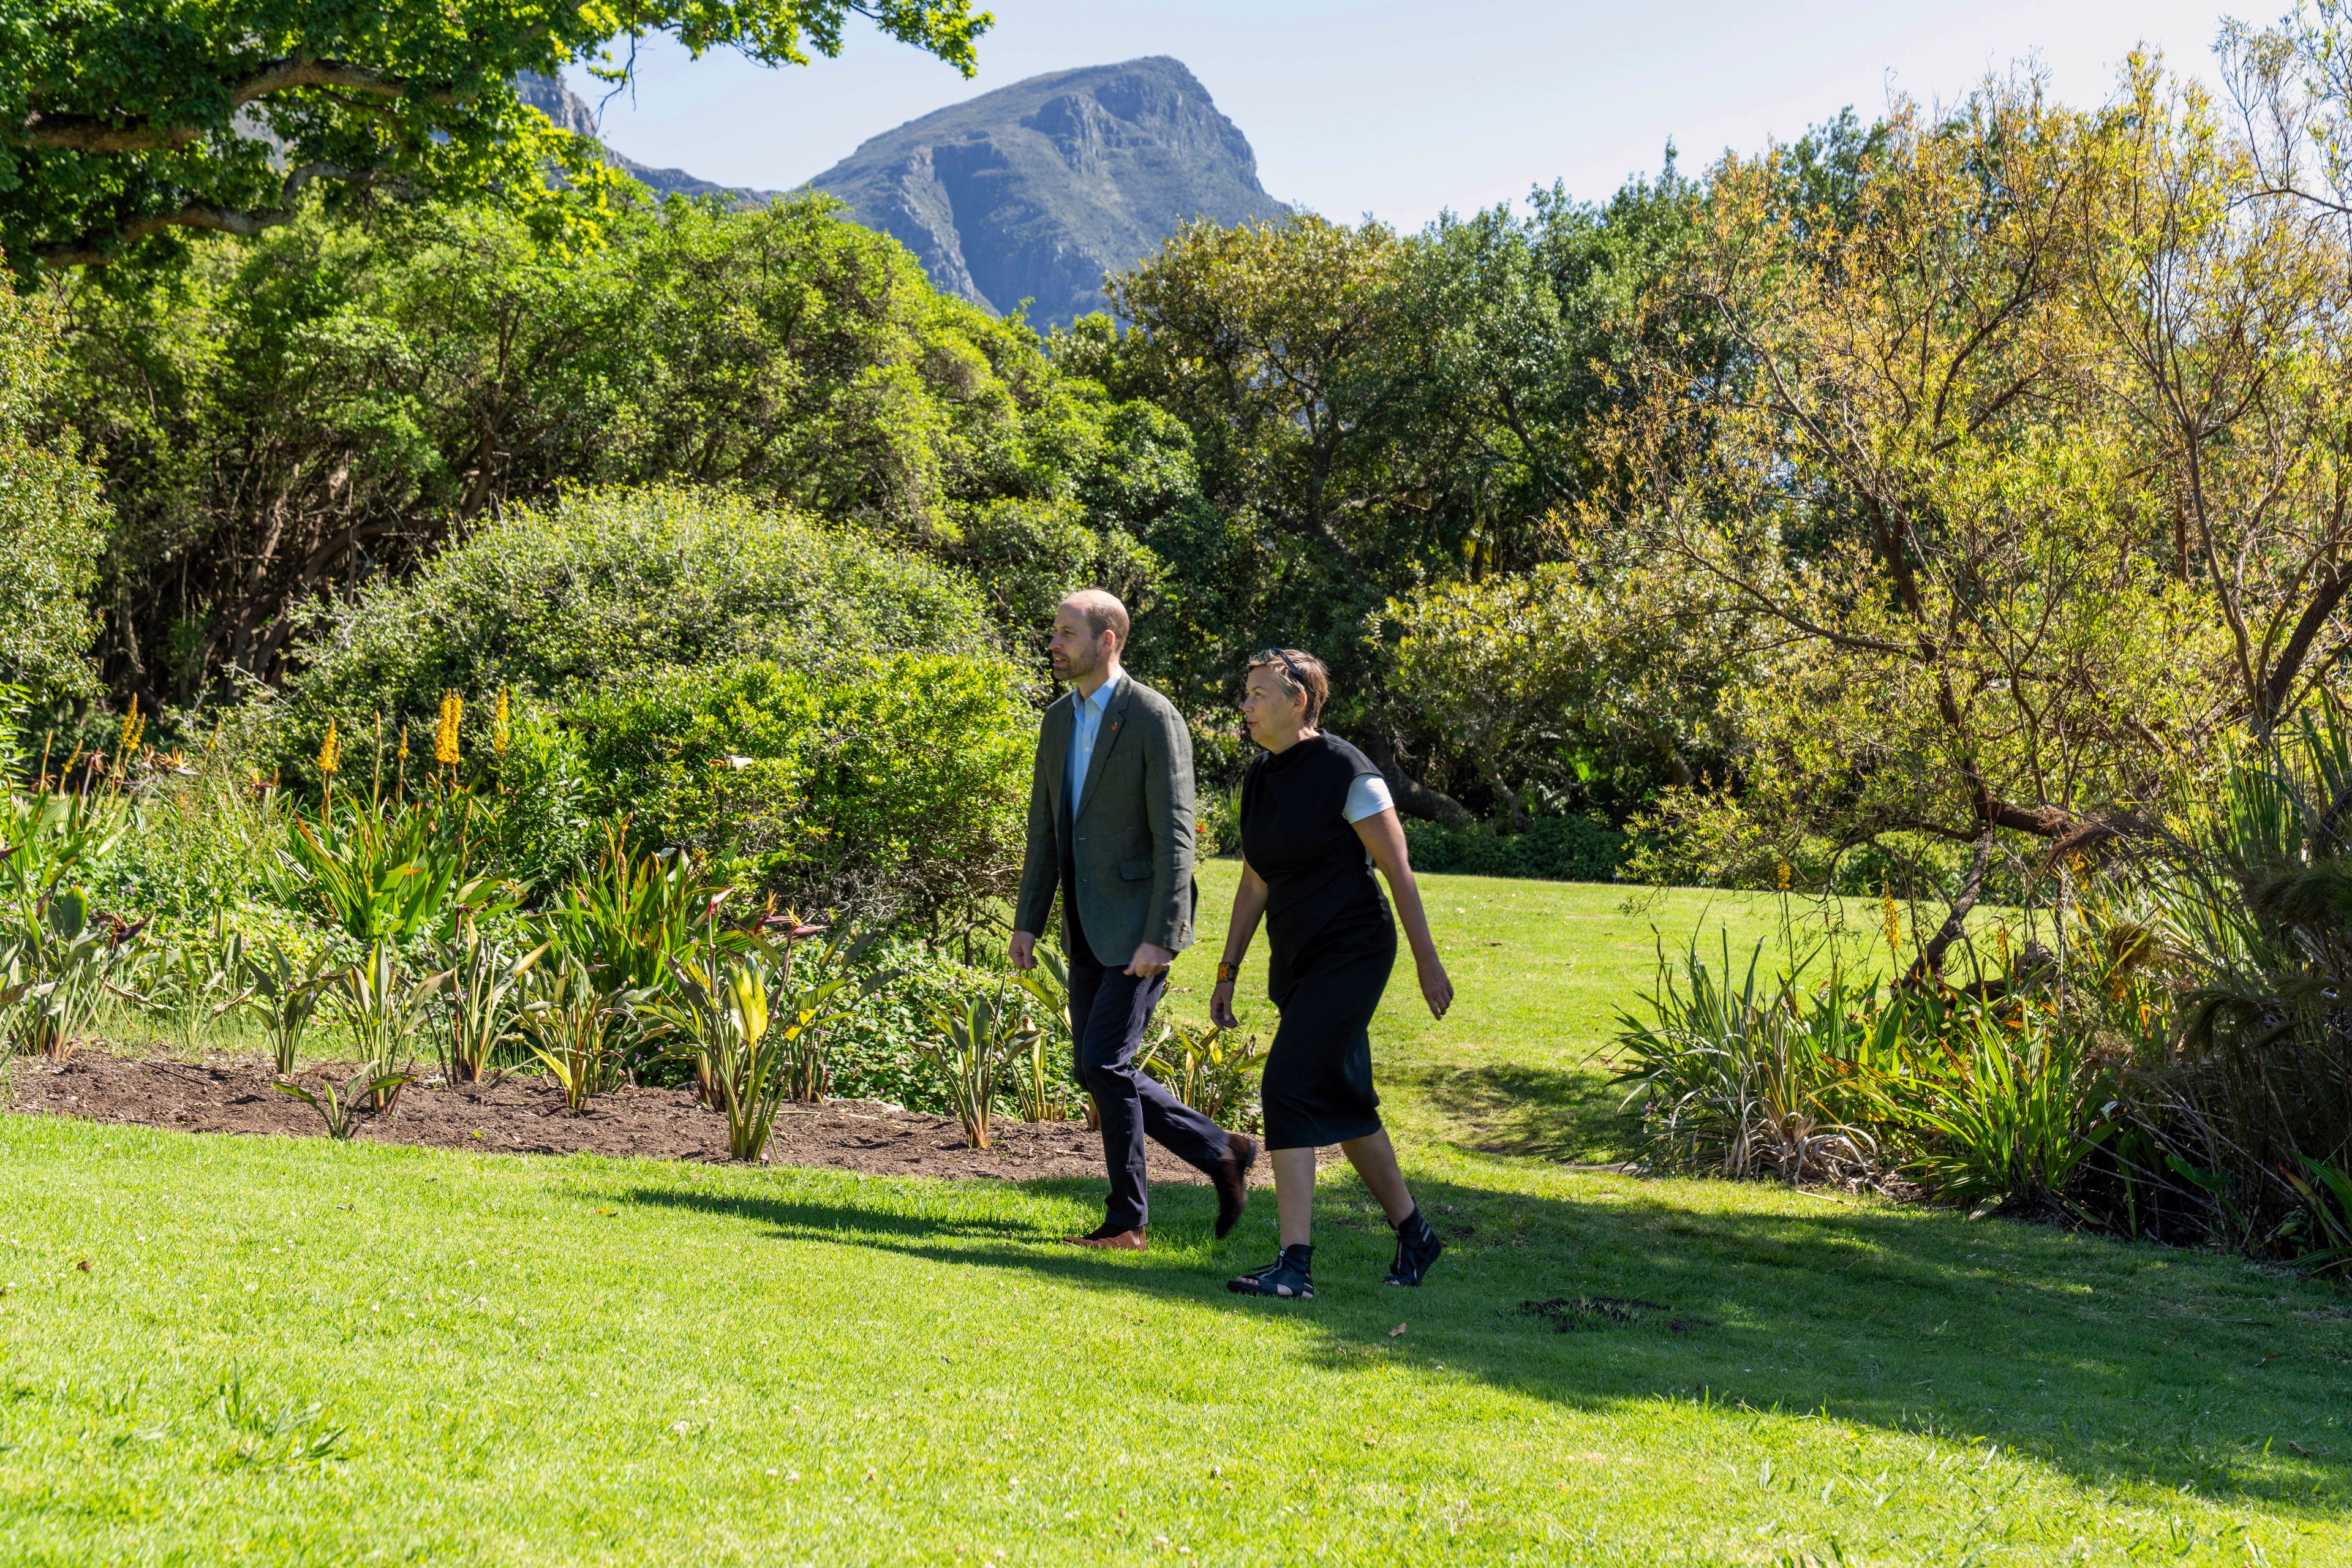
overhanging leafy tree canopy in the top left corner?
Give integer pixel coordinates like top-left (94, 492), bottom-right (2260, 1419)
top-left (0, 0), bottom-right (990, 268)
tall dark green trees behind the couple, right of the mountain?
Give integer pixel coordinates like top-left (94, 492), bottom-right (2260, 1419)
top-left (1056, 179), bottom-right (1708, 818)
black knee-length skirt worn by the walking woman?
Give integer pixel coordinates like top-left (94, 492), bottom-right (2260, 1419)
top-left (1261, 910), bottom-right (1397, 1150)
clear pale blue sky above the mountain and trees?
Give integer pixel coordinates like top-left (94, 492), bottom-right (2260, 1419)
top-left (574, 0), bottom-right (2239, 228)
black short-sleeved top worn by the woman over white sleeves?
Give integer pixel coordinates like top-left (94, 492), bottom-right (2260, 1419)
top-left (1242, 736), bottom-right (1397, 1004)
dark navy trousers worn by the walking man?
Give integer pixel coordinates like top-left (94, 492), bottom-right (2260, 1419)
top-left (1070, 900), bottom-right (1226, 1229)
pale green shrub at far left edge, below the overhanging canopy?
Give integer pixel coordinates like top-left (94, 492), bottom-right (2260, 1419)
top-left (0, 266), bottom-right (108, 691)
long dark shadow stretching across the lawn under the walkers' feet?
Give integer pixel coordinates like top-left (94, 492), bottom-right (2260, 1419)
top-left (621, 1175), bottom-right (2352, 1517)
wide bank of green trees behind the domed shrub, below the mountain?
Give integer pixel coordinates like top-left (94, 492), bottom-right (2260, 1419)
top-left (54, 197), bottom-right (1152, 707)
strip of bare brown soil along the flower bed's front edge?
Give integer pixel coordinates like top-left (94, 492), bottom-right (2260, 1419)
top-left (12, 1051), bottom-right (1272, 1183)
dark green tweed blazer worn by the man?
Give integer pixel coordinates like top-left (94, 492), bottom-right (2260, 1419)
top-left (1014, 675), bottom-right (1199, 968)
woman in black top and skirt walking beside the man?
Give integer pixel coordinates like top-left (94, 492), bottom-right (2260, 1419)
top-left (1209, 649), bottom-right (1453, 1300)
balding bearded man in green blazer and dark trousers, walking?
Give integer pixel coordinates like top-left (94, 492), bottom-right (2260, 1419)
top-left (1011, 588), bottom-right (1258, 1251)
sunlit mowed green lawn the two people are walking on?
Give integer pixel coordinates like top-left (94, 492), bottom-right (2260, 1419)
top-left (0, 867), bottom-right (2352, 1566)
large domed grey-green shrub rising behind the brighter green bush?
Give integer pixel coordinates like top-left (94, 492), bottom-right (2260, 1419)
top-left (279, 486), bottom-right (997, 776)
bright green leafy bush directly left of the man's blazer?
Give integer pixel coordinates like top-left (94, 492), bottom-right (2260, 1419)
top-left (574, 654), bottom-right (1035, 926)
